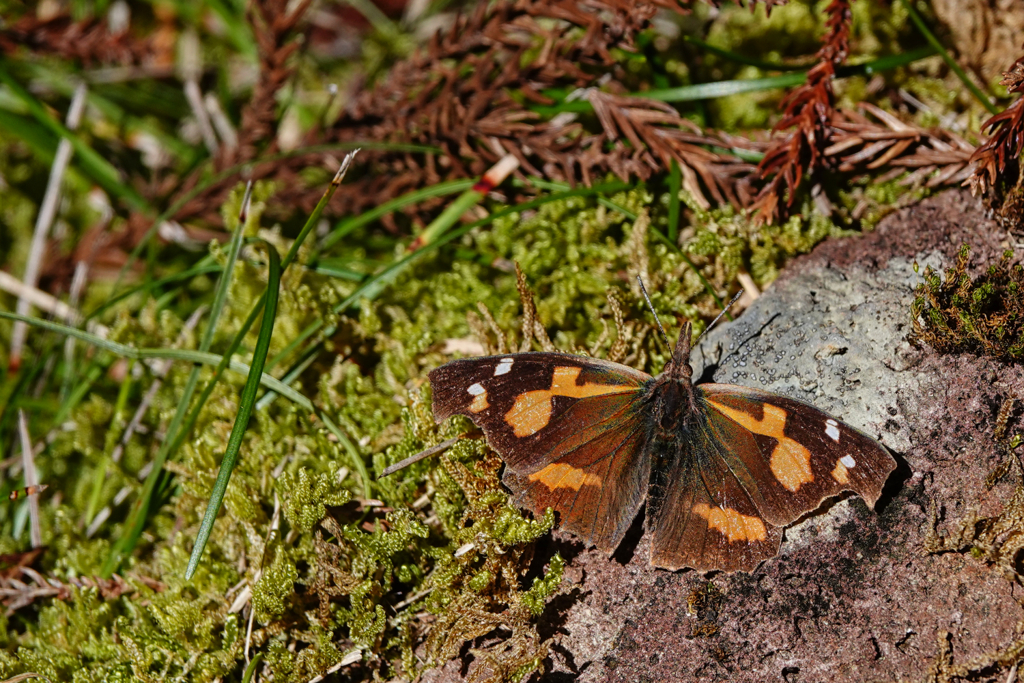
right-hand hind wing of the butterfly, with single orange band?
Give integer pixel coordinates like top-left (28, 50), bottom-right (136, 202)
top-left (645, 413), bottom-right (782, 571)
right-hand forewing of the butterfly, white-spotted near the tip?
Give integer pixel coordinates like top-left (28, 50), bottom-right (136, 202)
top-left (694, 384), bottom-right (896, 525)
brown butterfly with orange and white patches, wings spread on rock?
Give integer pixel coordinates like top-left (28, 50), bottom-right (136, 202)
top-left (429, 313), bottom-right (896, 571)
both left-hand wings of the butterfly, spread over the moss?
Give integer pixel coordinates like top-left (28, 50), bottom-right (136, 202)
top-left (430, 353), bottom-right (651, 552)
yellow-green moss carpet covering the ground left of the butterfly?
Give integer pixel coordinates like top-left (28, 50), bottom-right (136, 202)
top-left (0, 179), bottom-right (880, 681)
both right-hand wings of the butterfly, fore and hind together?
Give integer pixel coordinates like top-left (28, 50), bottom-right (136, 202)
top-left (646, 384), bottom-right (896, 571)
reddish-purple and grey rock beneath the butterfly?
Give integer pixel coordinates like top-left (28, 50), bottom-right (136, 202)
top-left (428, 193), bottom-right (1024, 683)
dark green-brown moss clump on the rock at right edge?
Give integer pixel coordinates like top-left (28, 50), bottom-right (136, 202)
top-left (910, 245), bottom-right (1024, 360)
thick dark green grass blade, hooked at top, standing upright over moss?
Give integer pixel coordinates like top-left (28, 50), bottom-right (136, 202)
top-left (185, 243), bottom-right (281, 580)
